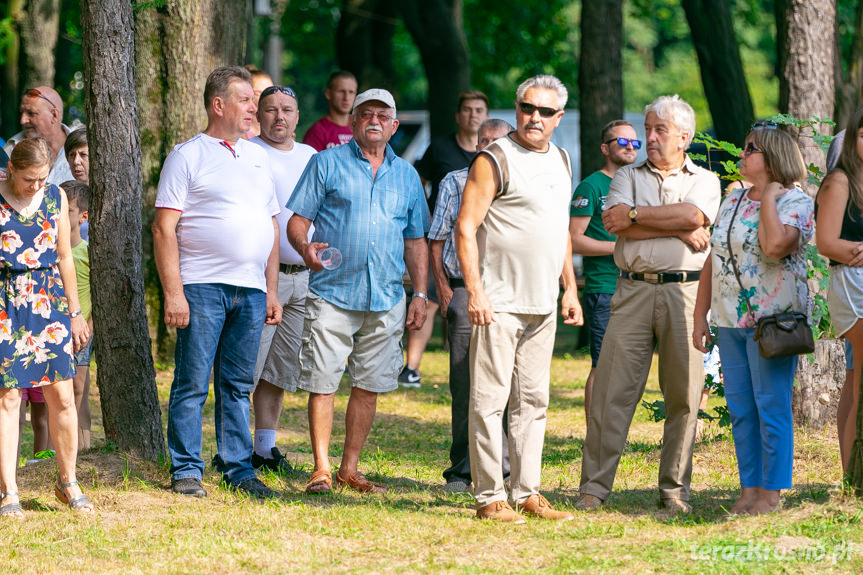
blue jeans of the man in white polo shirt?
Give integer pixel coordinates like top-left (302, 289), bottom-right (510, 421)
top-left (168, 284), bottom-right (267, 485)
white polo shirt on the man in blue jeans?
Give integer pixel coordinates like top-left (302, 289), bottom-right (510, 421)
top-left (156, 134), bottom-right (279, 291)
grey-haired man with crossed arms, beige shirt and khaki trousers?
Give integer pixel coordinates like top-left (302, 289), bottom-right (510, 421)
top-left (576, 96), bottom-right (720, 515)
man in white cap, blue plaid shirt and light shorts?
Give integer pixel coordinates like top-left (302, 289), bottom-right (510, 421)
top-left (286, 89), bottom-right (430, 493)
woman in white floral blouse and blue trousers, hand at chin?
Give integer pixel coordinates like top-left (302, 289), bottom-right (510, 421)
top-left (692, 124), bottom-right (814, 515)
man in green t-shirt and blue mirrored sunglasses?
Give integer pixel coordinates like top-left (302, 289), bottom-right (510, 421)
top-left (569, 120), bottom-right (641, 424)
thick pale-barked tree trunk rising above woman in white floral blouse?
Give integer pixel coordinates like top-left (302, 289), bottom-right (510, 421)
top-left (776, 0), bottom-right (836, 195)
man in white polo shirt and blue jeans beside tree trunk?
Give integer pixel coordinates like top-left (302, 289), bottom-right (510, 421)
top-left (153, 66), bottom-right (282, 497)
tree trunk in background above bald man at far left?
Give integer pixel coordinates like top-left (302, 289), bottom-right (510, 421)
top-left (20, 0), bottom-right (60, 88)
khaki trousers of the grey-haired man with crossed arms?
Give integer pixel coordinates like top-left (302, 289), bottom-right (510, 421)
top-left (579, 279), bottom-right (704, 501)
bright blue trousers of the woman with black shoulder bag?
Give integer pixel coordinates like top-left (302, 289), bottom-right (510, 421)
top-left (719, 327), bottom-right (797, 491)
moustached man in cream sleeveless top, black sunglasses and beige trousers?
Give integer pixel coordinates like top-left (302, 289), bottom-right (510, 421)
top-left (455, 75), bottom-right (582, 523)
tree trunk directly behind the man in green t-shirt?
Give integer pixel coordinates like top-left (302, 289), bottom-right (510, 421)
top-left (576, 0), bottom-right (623, 178)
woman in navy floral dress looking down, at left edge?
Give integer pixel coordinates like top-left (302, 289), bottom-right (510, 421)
top-left (0, 138), bottom-right (93, 517)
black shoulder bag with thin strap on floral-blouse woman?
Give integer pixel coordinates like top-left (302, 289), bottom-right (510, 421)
top-left (726, 192), bottom-right (815, 359)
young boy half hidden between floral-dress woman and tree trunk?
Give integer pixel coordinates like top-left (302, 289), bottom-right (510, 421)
top-left (60, 180), bottom-right (93, 451)
